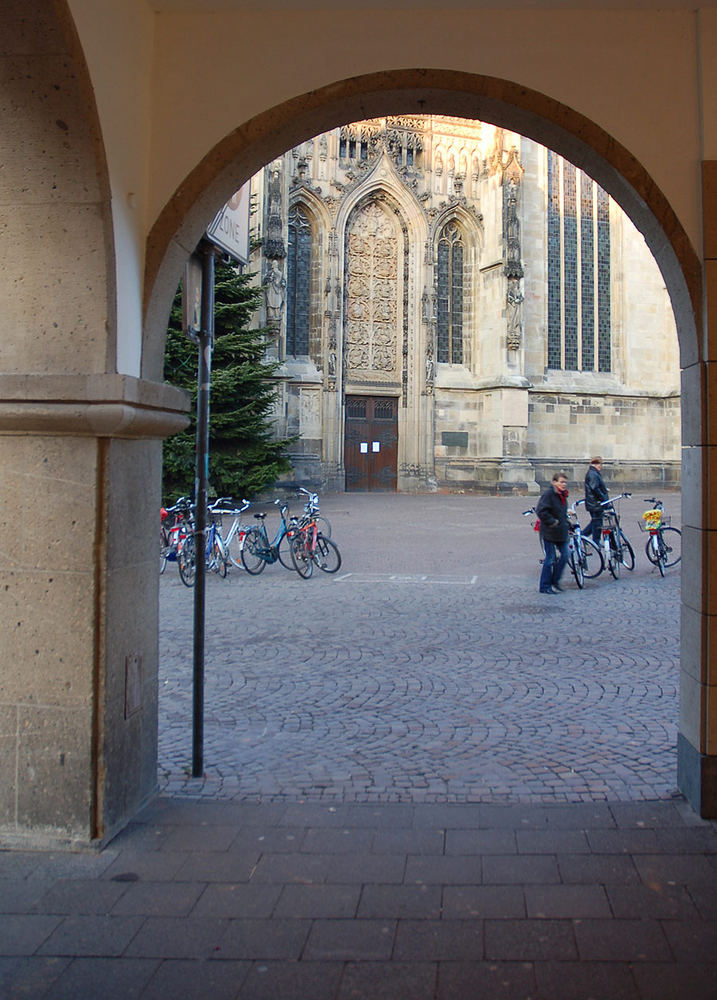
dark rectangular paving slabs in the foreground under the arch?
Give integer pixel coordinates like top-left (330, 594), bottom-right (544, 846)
top-left (0, 796), bottom-right (717, 1000)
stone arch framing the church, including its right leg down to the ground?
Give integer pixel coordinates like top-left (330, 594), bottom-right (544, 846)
top-left (143, 70), bottom-right (717, 815)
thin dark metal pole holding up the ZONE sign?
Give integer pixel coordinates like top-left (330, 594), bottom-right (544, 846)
top-left (192, 243), bottom-right (214, 778)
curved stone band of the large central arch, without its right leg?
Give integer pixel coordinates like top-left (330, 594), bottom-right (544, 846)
top-left (142, 69), bottom-right (702, 378)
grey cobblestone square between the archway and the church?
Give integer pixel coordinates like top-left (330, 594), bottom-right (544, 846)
top-left (160, 494), bottom-right (680, 803)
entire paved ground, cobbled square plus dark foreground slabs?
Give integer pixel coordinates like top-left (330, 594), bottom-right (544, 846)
top-left (0, 497), bottom-right (717, 1000)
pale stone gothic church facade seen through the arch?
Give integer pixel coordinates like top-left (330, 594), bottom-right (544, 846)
top-left (252, 116), bottom-right (680, 493)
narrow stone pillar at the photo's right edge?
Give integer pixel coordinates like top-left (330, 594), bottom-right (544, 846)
top-left (678, 166), bottom-right (717, 818)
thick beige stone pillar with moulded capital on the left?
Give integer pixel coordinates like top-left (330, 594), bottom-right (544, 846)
top-left (0, 375), bottom-right (186, 846)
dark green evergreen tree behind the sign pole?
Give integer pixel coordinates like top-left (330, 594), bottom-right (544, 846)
top-left (163, 261), bottom-right (290, 502)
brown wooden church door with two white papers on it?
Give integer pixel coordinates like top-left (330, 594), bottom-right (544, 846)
top-left (344, 396), bottom-right (398, 492)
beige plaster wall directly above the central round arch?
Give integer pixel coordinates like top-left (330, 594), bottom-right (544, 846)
top-left (148, 7), bottom-right (711, 252)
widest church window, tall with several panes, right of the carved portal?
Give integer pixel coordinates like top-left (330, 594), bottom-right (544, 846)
top-left (548, 152), bottom-right (612, 372)
